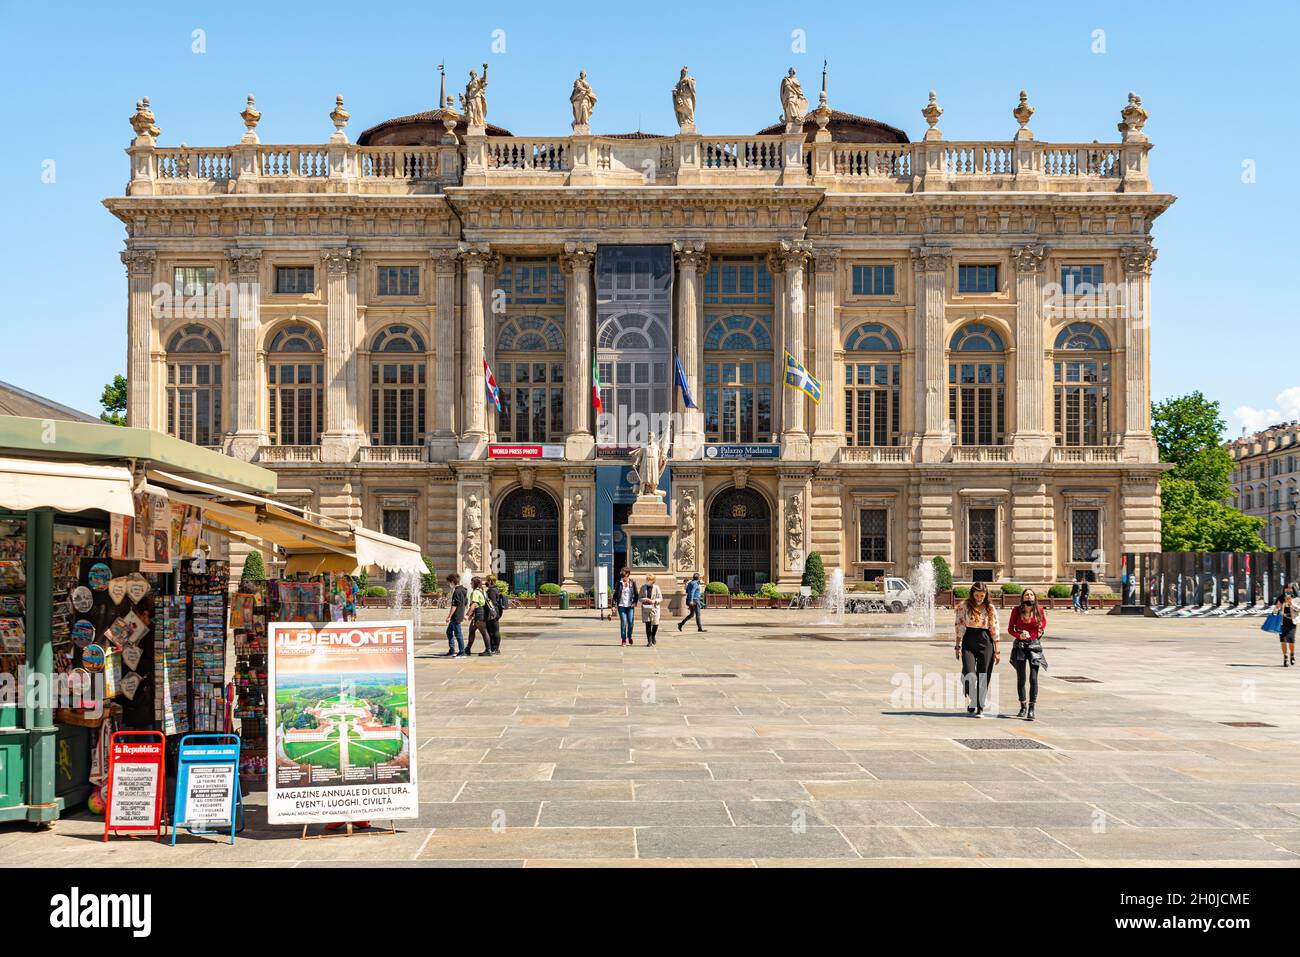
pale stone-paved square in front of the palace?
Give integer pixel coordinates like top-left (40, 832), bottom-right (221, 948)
top-left (0, 610), bottom-right (1300, 867)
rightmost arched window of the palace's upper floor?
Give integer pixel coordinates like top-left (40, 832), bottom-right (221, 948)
top-left (1052, 322), bottom-right (1110, 446)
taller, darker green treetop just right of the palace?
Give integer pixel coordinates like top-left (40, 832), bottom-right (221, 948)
top-left (1151, 391), bottom-right (1234, 502)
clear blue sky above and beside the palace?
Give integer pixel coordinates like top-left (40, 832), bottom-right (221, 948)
top-left (0, 0), bottom-right (1300, 434)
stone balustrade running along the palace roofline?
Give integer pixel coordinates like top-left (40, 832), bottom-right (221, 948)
top-left (127, 134), bottom-right (1152, 196)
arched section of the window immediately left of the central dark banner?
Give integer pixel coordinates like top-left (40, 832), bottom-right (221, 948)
top-left (494, 316), bottom-right (564, 442)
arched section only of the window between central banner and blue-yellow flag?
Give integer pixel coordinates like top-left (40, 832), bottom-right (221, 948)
top-left (705, 313), bottom-right (772, 442)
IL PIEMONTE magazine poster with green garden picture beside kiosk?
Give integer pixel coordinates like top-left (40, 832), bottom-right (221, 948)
top-left (268, 622), bottom-right (419, 824)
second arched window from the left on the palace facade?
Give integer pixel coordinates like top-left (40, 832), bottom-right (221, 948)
top-left (267, 325), bottom-right (325, 445)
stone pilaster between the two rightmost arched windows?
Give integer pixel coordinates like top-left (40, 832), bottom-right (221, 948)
top-left (1011, 244), bottom-right (1054, 460)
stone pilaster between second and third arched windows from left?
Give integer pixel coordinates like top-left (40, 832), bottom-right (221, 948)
top-left (321, 246), bottom-right (365, 462)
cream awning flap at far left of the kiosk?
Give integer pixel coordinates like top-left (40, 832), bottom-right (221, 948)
top-left (0, 458), bottom-right (135, 515)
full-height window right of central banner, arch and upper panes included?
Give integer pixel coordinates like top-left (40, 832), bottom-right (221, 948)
top-left (703, 256), bottom-right (775, 442)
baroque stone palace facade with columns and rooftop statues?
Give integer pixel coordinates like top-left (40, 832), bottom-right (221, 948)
top-left (105, 69), bottom-right (1174, 592)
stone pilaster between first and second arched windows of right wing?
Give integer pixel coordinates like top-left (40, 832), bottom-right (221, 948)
top-left (911, 246), bottom-right (953, 463)
